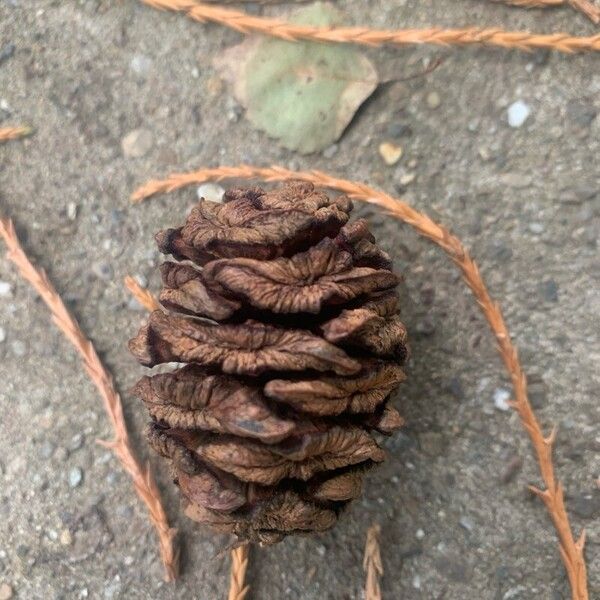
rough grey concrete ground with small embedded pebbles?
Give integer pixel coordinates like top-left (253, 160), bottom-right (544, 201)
top-left (0, 0), bottom-right (600, 600)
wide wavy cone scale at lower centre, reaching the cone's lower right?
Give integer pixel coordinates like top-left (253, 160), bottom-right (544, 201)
top-left (196, 426), bottom-right (385, 485)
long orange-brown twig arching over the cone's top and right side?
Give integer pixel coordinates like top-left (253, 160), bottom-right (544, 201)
top-left (132, 165), bottom-right (588, 600)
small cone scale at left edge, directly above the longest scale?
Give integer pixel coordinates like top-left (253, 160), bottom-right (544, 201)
top-left (159, 262), bottom-right (240, 321)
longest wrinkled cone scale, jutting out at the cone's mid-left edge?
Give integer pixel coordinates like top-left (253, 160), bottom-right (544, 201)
top-left (129, 311), bottom-right (360, 375)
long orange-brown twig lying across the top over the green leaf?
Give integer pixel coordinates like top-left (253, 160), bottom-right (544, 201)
top-left (140, 0), bottom-right (600, 53)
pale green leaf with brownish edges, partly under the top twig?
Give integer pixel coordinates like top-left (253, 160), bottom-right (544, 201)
top-left (216, 2), bottom-right (378, 154)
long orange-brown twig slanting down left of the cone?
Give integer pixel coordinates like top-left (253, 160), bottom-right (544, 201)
top-left (0, 219), bottom-right (178, 581)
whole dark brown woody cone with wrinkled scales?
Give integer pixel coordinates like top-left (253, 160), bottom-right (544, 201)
top-left (129, 182), bottom-right (408, 543)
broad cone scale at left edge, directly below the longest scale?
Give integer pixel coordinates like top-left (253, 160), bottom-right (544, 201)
top-left (132, 365), bottom-right (301, 444)
